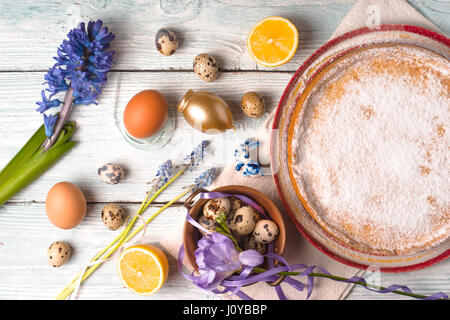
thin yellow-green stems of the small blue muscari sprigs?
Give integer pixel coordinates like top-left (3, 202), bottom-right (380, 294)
top-left (56, 165), bottom-right (192, 300)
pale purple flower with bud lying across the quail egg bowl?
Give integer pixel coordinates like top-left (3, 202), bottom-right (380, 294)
top-left (194, 232), bottom-right (264, 290)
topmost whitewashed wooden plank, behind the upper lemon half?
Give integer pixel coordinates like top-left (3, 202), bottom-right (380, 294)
top-left (0, 0), bottom-right (450, 71)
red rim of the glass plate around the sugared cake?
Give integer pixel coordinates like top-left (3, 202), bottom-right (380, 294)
top-left (270, 24), bottom-right (450, 273)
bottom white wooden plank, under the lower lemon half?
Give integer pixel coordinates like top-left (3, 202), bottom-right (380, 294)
top-left (0, 203), bottom-right (450, 300)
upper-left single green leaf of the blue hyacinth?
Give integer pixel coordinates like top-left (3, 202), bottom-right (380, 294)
top-left (0, 125), bottom-right (47, 185)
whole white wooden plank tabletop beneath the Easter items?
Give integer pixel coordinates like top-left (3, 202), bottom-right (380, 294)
top-left (0, 0), bottom-right (450, 299)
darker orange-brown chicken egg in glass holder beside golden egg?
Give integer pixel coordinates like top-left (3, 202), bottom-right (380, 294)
top-left (123, 90), bottom-right (169, 138)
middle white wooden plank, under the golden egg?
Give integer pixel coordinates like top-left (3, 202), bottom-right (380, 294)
top-left (0, 72), bottom-right (291, 202)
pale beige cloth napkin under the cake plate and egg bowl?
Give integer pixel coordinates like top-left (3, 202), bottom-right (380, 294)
top-left (161, 0), bottom-right (439, 300)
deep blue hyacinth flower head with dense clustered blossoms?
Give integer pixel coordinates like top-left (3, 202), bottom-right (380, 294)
top-left (37, 20), bottom-right (114, 136)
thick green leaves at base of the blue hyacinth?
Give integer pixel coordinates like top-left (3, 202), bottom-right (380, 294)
top-left (0, 122), bottom-right (76, 206)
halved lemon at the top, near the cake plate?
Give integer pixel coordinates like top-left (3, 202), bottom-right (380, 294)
top-left (247, 16), bottom-right (298, 67)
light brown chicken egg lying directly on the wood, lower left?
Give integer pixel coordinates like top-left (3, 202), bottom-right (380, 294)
top-left (45, 182), bottom-right (86, 229)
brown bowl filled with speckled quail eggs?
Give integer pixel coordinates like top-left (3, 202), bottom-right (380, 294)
top-left (183, 185), bottom-right (286, 270)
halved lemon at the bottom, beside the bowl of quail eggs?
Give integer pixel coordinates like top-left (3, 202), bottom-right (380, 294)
top-left (118, 244), bottom-right (169, 296)
